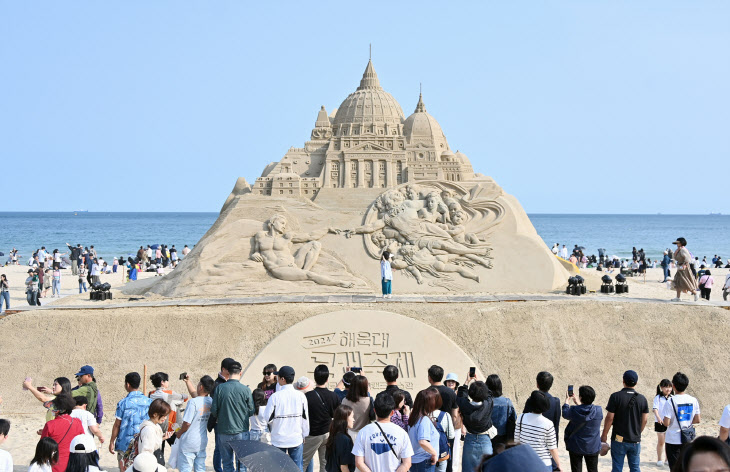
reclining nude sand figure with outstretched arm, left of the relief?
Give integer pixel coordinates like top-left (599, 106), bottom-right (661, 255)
top-left (251, 215), bottom-right (354, 288)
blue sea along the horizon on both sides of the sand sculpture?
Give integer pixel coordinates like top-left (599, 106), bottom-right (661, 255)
top-left (0, 212), bottom-right (730, 265)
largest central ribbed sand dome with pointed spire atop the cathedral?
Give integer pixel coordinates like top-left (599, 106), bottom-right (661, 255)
top-left (333, 61), bottom-right (404, 126)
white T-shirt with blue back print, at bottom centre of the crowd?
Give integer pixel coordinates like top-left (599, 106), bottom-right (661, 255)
top-left (352, 422), bottom-right (413, 471)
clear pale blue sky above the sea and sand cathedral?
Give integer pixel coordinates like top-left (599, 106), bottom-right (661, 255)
top-left (0, 0), bottom-right (730, 213)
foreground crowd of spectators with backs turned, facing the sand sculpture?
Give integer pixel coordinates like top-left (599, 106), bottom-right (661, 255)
top-left (0, 358), bottom-right (730, 472)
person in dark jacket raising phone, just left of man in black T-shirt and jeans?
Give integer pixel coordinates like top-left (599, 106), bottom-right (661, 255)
top-left (563, 385), bottom-right (603, 472)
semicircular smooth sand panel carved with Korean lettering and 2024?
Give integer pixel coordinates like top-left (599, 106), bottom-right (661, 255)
top-left (237, 310), bottom-right (484, 394)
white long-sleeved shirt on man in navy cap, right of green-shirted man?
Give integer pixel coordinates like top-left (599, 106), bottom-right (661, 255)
top-left (264, 384), bottom-right (309, 447)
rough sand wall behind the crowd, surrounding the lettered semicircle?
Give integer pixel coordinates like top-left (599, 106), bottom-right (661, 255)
top-left (0, 302), bottom-right (730, 420)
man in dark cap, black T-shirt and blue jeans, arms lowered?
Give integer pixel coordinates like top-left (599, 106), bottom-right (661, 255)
top-left (601, 370), bottom-right (649, 472)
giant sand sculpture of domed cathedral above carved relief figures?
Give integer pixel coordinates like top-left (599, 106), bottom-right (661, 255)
top-left (125, 58), bottom-right (569, 297)
